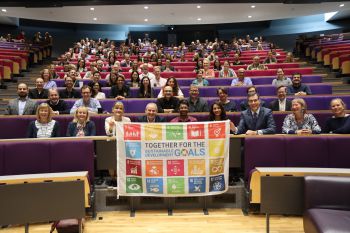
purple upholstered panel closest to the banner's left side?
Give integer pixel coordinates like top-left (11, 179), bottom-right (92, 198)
top-left (50, 140), bottom-right (94, 182)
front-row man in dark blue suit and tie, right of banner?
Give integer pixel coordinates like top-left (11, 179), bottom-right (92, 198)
top-left (233, 93), bottom-right (276, 135)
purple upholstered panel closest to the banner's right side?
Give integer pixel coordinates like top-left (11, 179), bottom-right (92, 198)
top-left (244, 137), bottom-right (286, 179)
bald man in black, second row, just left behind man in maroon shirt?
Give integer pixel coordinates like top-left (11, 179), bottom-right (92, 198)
top-left (157, 86), bottom-right (179, 113)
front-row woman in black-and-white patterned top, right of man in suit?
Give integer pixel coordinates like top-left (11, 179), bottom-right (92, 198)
top-left (282, 98), bottom-right (321, 135)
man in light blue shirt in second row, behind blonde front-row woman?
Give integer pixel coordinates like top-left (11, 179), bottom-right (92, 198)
top-left (70, 85), bottom-right (102, 114)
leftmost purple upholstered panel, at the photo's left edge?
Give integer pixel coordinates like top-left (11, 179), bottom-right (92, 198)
top-left (0, 141), bottom-right (51, 175)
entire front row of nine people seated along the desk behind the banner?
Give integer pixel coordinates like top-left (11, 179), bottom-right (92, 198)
top-left (27, 93), bottom-right (350, 138)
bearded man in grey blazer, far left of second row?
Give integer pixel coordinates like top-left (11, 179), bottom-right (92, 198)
top-left (5, 83), bottom-right (37, 115)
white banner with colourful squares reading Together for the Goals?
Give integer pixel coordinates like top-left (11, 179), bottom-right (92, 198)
top-left (116, 121), bottom-right (230, 197)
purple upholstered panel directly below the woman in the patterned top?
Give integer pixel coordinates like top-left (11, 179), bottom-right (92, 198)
top-left (286, 136), bottom-right (329, 167)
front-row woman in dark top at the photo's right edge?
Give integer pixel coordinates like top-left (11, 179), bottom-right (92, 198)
top-left (323, 98), bottom-right (350, 134)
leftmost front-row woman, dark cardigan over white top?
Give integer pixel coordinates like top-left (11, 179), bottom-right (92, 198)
top-left (27, 103), bottom-right (60, 138)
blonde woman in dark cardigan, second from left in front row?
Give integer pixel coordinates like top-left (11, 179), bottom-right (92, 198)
top-left (67, 107), bottom-right (96, 137)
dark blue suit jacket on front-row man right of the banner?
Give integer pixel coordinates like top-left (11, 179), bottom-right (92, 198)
top-left (237, 107), bottom-right (276, 134)
